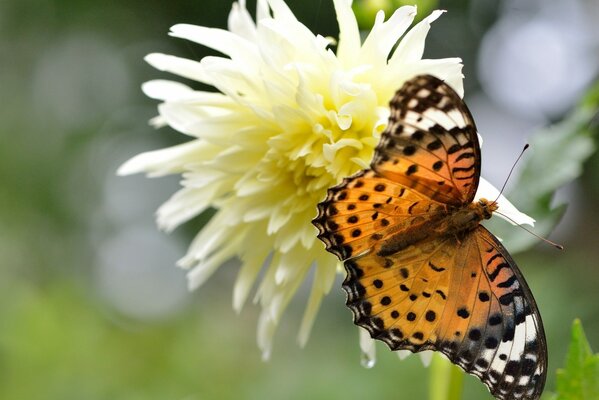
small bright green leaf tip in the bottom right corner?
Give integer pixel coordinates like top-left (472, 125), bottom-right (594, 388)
top-left (553, 319), bottom-right (599, 400)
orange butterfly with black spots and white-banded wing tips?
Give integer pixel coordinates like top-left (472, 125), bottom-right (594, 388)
top-left (312, 75), bottom-right (547, 400)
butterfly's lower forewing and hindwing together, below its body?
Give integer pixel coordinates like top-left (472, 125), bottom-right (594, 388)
top-left (343, 226), bottom-right (547, 400)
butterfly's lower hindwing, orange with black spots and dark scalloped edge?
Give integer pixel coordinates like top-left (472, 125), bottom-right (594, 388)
top-left (343, 234), bottom-right (454, 351)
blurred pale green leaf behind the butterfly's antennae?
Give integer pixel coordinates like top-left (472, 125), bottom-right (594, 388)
top-left (489, 79), bottom-right (599, 252)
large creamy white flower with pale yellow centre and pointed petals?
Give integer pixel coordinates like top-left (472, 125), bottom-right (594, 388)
top-left (118, 0), bottom-right (532, 359)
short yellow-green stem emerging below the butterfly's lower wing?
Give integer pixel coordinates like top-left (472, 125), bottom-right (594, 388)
top-left (429, 353), bottom-right (464, 400)
